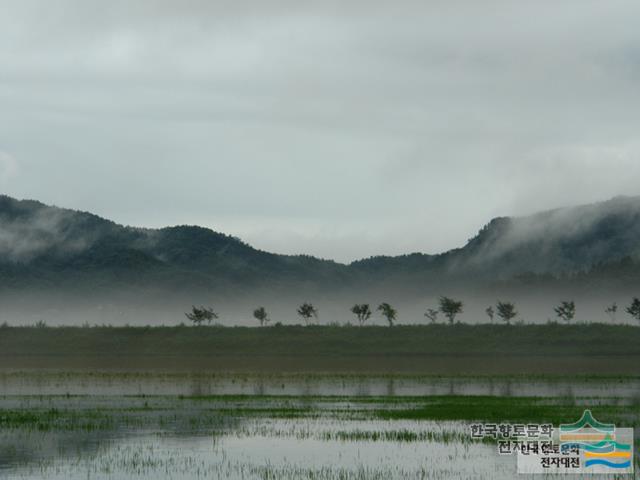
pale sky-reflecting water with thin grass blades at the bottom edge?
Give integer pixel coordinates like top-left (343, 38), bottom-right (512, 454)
top-left (0, 419), bottom-right (516, 480)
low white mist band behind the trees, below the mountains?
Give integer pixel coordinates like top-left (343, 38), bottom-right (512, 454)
top-left (0, 291), bottom-right (640, 326)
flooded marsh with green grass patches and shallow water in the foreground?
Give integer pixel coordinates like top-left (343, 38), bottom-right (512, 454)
top-left (0, 372), bottom-right (640, 479)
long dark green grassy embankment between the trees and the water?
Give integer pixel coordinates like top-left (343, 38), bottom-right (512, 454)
top-left (0, 324), bottom-right (640, 375)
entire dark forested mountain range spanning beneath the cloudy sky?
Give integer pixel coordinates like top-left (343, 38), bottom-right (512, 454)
top-left (0, 196), bottom-right (640, 294)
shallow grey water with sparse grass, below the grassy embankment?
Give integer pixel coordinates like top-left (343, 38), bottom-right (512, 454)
top-left (0, 372), bottom-right (639, 480)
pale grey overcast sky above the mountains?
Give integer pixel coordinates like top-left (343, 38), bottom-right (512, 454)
top-left (0, 0), bottom-right (640, 261)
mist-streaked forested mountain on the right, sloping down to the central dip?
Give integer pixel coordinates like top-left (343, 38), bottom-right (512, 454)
top-left (352, 197), bottom-right (640, 281)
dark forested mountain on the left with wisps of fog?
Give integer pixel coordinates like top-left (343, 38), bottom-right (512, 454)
top-left (0, 196), bottom-right (346, 289)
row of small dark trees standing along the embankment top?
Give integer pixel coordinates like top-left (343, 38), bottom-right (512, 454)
top-left (185, 296), bottom-right (640, 327)
